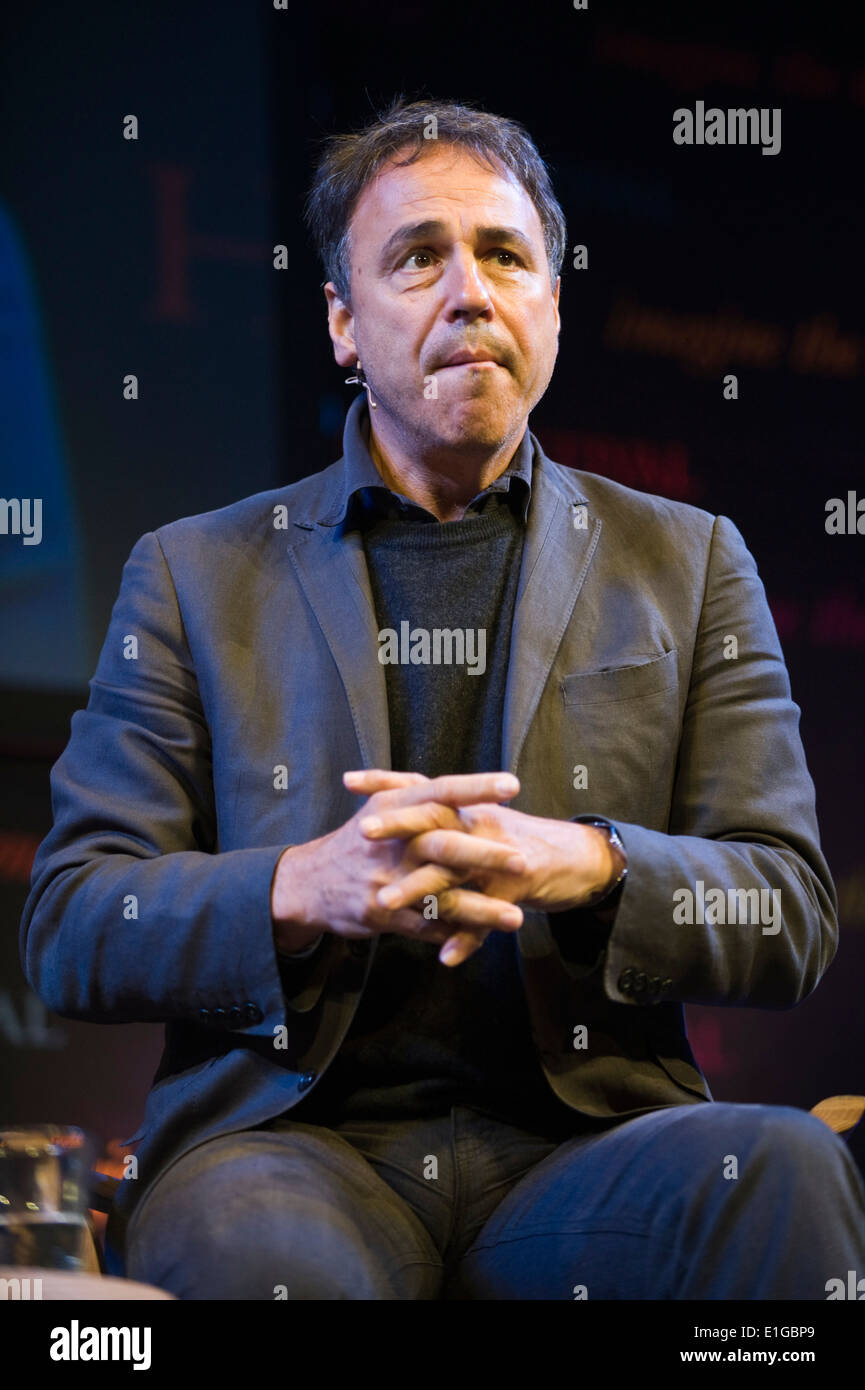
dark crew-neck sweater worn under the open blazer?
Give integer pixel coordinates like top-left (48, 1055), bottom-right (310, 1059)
top-left (291, 488), bottom-right (589, 1136)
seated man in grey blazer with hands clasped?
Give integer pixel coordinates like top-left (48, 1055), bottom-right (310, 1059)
top-left (22, 101), bottom-right (865, 1300)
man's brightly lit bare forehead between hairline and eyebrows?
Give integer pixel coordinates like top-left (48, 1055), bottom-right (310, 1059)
top-left (352, 140), bottom-right (544, 246)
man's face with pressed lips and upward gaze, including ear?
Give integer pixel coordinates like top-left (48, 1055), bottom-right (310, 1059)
top-left (325, 140), bottom-right (560, 450)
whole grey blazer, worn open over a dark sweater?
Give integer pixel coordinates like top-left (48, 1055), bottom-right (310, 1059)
top-left (21, 408), bottom-right (837, 1248)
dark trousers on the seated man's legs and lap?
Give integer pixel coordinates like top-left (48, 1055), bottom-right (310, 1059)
top-left (125, 1102), bottom-right (865, 1300)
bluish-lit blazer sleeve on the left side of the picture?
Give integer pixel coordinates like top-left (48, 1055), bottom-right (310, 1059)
top-left (19, 532), bottom-right (304, 1036)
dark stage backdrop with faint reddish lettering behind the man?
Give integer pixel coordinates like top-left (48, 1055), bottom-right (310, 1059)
top-left (0, 0), bottom-right (865, 1163)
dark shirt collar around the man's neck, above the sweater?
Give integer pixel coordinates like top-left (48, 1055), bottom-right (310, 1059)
top-left (332, 392), bottom-right (534, 525)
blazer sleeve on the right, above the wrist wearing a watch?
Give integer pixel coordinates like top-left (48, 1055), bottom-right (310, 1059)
top-left (556, 516), bottom-right (839, 1009)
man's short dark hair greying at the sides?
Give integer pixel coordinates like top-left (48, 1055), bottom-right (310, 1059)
top-left (303, 96), bottom-right (567, 304)
